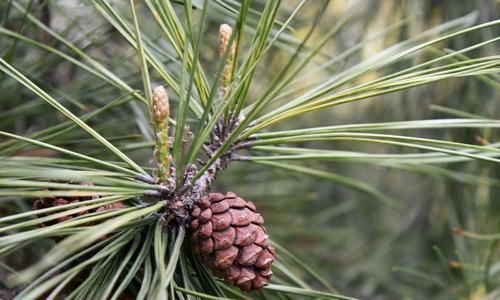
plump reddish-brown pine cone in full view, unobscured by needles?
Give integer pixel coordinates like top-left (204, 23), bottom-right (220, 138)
top-left (190, 192), bottom-right (275, 292)
